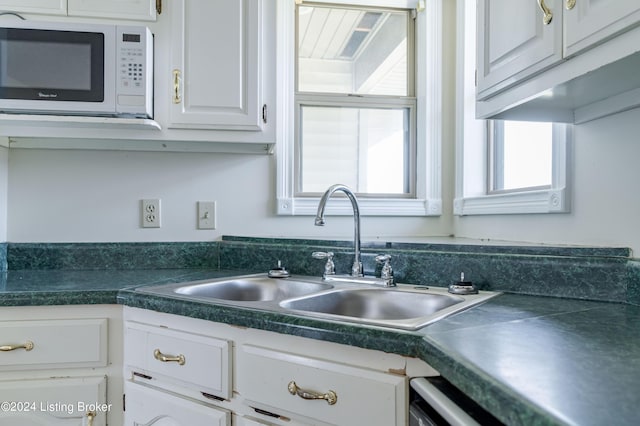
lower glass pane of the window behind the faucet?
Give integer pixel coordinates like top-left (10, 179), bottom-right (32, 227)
top-left (298, 106), bottom-right (410, 194)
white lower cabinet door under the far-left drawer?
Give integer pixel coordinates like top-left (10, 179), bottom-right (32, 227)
top-left (0, 377), bottom-right (111, 426)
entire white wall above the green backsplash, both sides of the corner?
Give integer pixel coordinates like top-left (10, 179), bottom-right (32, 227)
top-left (0, 109), bottom-right (640, 251)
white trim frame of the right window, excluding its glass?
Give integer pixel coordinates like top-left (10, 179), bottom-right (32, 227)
top-left (453, 0), bottom-right (572, 216)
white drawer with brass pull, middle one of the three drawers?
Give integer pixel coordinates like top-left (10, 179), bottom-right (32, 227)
top-left (125, 323), bottom-right (231, 399)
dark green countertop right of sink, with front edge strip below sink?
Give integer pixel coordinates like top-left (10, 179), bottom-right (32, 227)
top-left (119, 290), bottom-right (640, 426)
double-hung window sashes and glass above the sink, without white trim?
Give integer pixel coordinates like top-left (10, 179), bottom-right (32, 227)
top-left (294, 3), bottom-right (416, 196)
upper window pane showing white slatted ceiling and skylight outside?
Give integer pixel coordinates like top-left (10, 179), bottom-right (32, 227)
top-left (297, 6), bottom-right (409, 96)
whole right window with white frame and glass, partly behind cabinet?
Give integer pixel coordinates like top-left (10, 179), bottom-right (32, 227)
top-left (454, 0), bottom-right (571, 215)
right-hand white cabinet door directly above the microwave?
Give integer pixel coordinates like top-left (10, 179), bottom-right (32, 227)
top-left (68, 0), bottom-right (156, 21)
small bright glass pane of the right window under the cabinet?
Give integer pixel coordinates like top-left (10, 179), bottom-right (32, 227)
top-left (496, 121), bottom-right (553, 190)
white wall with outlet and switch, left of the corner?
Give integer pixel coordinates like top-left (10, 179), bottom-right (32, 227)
top-left (6, 149), bottom-right (450, 242)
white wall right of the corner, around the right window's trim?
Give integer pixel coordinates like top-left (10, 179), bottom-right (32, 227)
top-left (455, 109), bottom-right (640, 252)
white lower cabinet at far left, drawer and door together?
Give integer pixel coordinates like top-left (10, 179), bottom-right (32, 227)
top-left (0, 305), bottom-right (122, 426)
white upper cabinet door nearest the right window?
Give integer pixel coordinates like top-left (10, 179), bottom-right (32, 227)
top-left (477, 0), bottom-right (562, 99)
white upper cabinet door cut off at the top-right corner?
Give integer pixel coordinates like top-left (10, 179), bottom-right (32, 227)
top-left (562, 0), bottom-right (640, 56)
